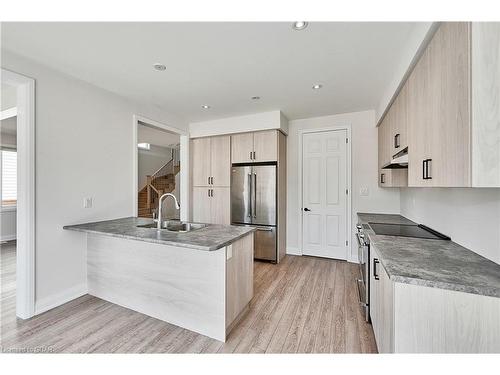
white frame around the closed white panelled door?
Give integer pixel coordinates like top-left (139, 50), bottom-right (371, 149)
top-left (297, 124), bottom-right (352, 261)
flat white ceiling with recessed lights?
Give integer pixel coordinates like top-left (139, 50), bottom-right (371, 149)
top-left (1, 22), bottom-right (416, 122)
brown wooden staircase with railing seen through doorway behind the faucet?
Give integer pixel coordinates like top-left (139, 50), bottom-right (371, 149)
top-left (137, 145), bottom-right (181, 218)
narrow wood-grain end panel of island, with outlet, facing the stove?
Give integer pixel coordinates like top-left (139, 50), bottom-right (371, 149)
top-left (226, 232), bottom-right (254, 335)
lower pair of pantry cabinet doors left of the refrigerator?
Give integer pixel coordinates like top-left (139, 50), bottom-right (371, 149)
top-left (193, 186), bottom-right (231, 225)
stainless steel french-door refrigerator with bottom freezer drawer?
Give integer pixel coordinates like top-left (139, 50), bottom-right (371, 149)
top-left (231, 164), bottom-right (277, 262)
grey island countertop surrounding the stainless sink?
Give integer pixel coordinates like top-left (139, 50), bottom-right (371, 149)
top-left (63, 217), bottom-right (255, 251)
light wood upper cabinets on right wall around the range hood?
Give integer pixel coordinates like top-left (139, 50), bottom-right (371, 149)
top-left (379, 22), bottom-right (500, 187)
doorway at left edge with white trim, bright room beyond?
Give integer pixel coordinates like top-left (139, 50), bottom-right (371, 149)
top-left (0, 69), bottom-right (35, 318)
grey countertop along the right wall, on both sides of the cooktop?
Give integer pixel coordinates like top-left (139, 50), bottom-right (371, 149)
top-left (358, 213), bottom-right (500, 298)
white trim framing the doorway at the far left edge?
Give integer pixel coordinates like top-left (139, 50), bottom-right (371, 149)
top-left (1, 68), bottom-right (36, 319)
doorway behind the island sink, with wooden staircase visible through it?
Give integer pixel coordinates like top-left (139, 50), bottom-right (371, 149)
top-left (134, 116), bottom-right (188, 220)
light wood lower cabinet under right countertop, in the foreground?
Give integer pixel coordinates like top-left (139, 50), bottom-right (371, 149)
top-left (370, 246), bottom-right (500, 353)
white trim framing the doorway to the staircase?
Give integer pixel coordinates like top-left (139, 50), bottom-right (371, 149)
top-left (132, 115), bottom-right (190, 221)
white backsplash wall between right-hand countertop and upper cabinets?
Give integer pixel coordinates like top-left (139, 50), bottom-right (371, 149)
top-left (401, 188), bottom-right (500, 263)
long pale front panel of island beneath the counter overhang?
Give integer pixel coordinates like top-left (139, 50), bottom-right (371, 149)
top-left (87, 235), bottom-right (226, 341)
